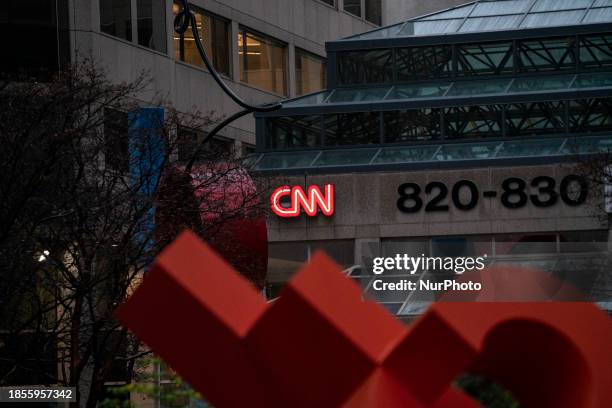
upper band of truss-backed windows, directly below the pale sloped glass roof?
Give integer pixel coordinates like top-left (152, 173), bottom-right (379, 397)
top-left (337, 34), bottom-right (612, 85)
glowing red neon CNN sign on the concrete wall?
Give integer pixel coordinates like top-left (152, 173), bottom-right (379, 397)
top-left (270, 184), bottom-right (334, 218)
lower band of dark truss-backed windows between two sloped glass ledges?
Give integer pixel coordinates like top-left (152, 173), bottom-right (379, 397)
top-left (265, 98), bottom-right (612, 149)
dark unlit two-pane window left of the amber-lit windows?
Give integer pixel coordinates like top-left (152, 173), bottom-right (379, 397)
top-left (100, 0), bottom-right (166, 52)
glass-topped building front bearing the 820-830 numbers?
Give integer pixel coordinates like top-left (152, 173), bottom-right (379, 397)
top-left (253, 0), bottom-right (612, 319)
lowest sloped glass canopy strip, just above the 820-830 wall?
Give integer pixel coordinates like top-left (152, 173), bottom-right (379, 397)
top-left (249, 136), bottom-right (612, 171)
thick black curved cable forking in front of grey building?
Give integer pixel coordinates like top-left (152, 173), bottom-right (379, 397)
top-left (174, 0), bottom-right (282, 173)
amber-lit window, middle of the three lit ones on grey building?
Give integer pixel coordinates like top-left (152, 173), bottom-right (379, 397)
top-left (238, 29), bottom-right (287, 95)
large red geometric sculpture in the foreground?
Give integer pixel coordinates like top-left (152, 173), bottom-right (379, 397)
top-left (117, 232), bottom-right (612, 408)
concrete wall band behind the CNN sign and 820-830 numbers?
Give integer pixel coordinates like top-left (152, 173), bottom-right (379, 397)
top-left (269, 165), bottom-right (607, 241)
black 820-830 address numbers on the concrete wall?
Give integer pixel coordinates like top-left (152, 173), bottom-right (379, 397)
top-left (397, 174), bottom-right (589, 213)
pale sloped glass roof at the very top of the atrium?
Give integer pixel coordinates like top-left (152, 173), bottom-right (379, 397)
top-left (344, 0), bottom-right (612, 41)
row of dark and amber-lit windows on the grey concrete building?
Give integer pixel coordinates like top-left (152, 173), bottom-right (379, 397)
top-left (100, 0), bottom-right (326, 96)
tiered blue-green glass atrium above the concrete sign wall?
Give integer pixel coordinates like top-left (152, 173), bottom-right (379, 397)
top-left (250, 0), bottom-right (612, 173)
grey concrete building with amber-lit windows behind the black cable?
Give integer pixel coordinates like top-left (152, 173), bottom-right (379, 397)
top-left (0, 0), bottom-right (392, 159)
